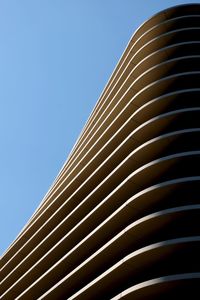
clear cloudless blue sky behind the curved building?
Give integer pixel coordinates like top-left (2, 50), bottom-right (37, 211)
top-left (0, 0), bottom-right (200, 254)
